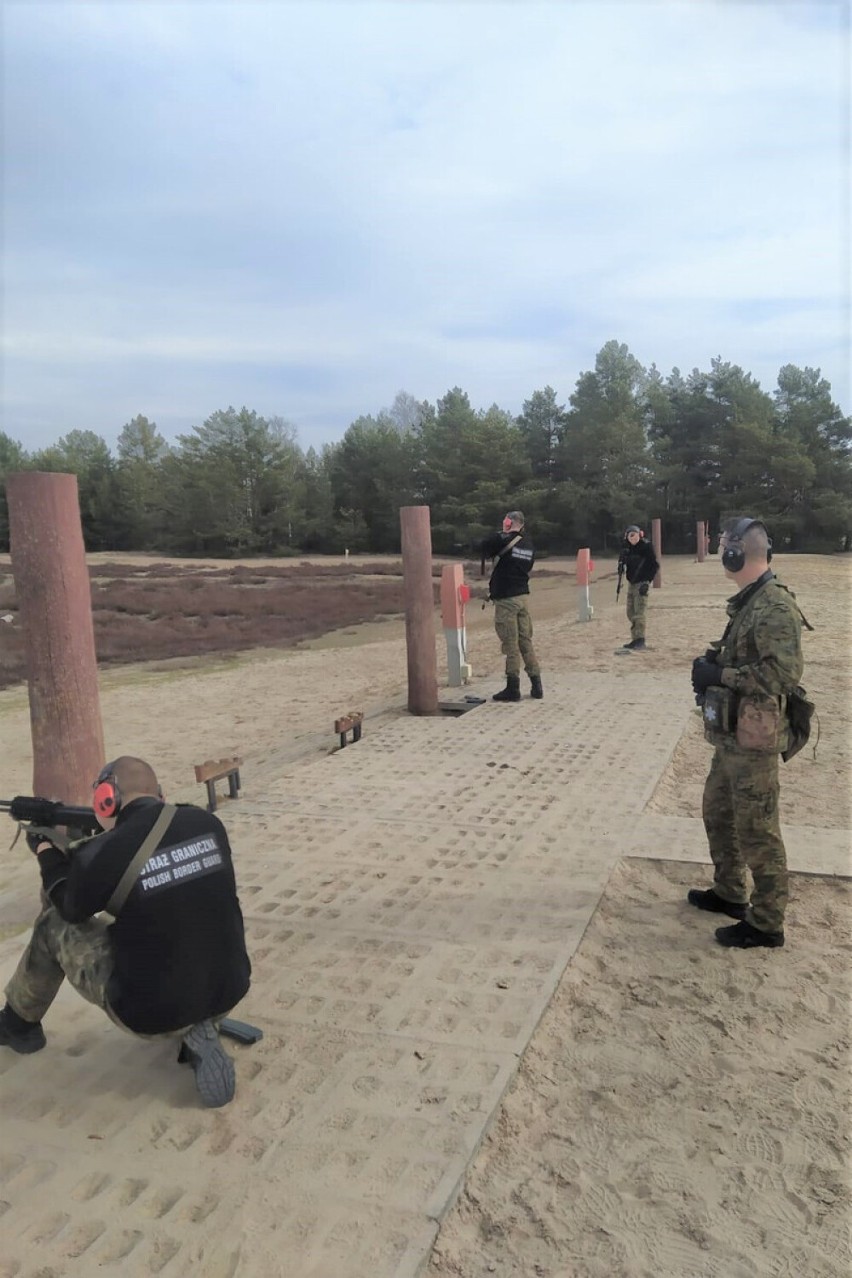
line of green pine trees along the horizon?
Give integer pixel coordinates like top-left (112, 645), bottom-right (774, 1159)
top-left (0, 341), bottom-right (852, 557)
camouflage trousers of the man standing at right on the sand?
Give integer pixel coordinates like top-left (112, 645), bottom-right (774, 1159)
top-left (703, 740), bottom-right (787, 932)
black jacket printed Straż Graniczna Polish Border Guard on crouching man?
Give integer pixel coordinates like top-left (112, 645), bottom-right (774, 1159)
top-left (38, 799), bottom-right (252, 1034)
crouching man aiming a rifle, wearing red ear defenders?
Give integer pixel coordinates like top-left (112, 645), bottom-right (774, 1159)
top-left (0, 755), bottom-right (252, 1107)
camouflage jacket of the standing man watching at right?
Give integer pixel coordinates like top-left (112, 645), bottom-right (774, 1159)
top-left (713, 573), bottom-right (803, 749)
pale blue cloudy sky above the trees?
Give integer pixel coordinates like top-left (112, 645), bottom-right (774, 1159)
top-left (1, 0), bottom-right (852, 449)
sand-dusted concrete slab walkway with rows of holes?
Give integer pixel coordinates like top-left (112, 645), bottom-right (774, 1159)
top-left (0, 674), bottom-right (848, 1278)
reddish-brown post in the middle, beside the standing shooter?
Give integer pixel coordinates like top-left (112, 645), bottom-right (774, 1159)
top-left (400, 506), bottom-right (438, 714)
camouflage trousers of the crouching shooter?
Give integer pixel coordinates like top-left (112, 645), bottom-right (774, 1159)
top-left (6, 905), bottom-right (130, 1033)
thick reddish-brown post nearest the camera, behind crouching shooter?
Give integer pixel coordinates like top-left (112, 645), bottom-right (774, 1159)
top-left (6, 472), bottom-right (103, 805)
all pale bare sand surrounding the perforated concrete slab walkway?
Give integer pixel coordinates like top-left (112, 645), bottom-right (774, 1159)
top-left (0, 556), bottom-right (852, 1278)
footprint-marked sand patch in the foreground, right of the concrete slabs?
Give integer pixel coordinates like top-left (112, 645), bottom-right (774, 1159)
top-left (429, 860), bottom-right (852, 1278)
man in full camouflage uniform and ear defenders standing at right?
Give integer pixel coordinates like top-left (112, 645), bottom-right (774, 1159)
top-left (687, 519), bottom-right (802, 948)
